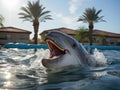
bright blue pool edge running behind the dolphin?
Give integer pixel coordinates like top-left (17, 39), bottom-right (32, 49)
top-left (4, 43), bottom-right (120, 50)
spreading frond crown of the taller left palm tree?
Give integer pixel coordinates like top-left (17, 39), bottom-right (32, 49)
top-left (18, 0), bottom-right (52, 21)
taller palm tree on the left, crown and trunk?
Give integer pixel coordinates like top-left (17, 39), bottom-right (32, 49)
top-left (19, 0), bottom-right (52, 44)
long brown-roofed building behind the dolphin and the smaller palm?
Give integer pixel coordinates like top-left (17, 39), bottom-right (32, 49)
top-left (40, 27), bottom-right (120, 45)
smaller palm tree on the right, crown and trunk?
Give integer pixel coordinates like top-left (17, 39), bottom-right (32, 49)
top-left (78, 7), bottom-right (105, 45)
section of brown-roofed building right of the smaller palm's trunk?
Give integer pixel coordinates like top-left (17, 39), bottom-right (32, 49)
top-left (93, 30), bottom-right (120, 45)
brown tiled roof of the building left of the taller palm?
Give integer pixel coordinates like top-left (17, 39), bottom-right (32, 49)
top-left (0, 27), bottom-right (31, 34)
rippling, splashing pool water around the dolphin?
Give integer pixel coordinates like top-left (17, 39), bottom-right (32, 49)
top-left (0, 48), bottom-right (120, 90)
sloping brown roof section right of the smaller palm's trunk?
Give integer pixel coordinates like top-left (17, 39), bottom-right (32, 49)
top-left (93, 30), bottom-right (120, 37)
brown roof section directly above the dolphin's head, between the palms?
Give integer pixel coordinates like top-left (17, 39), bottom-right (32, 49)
top-left (42, 27), bottom-right (76, 35)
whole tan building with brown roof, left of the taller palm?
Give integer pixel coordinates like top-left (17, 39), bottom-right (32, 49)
top-left (0, 27), bottom-right (31, 45)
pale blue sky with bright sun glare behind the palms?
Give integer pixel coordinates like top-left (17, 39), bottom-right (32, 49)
top-left (0, 0), bottom-right (120, 38)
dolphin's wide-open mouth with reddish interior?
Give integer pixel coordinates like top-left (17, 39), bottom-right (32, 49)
top-left (46, 39), bottom-right (68, 60)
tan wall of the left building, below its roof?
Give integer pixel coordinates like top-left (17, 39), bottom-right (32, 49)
top-left (0, 32), bottom-right (29, 44)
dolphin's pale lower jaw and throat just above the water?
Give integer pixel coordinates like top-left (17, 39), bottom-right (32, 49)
top-left (42, 55), bottom-right (81, 69)
